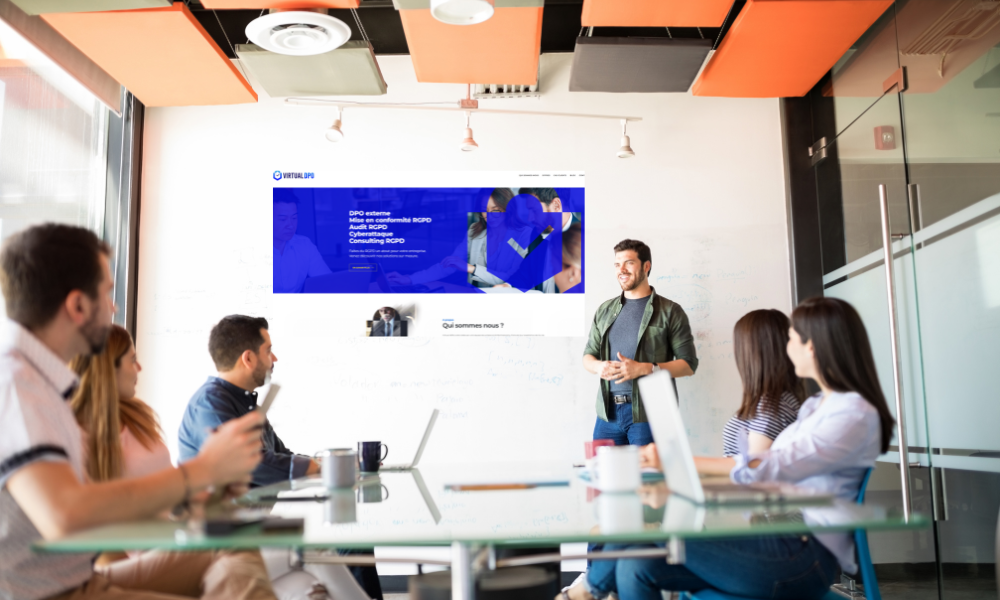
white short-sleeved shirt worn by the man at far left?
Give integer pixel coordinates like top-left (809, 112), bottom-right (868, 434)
top-left (0, 321), bottom-right (94, 600)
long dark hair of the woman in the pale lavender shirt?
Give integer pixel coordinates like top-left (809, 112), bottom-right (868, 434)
top-left (792, 298), bottom-right (896, 452)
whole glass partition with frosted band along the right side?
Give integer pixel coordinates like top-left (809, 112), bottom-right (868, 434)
top-left (811, 0), bottom-right (1000, 600)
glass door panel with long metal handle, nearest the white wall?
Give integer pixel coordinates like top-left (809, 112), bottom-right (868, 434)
top-left (815, 88), bottom-right (938, 599)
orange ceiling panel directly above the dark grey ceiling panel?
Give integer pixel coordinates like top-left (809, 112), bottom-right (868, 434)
top-left (580, 0), bottom-right (733, 27)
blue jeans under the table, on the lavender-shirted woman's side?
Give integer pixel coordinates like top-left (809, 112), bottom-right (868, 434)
top-left (587, 535), bottom-right (839, 600)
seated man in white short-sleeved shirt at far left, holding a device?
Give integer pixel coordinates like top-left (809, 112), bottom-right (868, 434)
top-left (0, 224), bottom-right (274, 600)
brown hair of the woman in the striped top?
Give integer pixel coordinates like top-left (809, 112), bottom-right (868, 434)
top-left (733, 309), bottom-right (805, 421)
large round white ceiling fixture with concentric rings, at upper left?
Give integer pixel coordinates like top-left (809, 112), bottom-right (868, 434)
top-left (246, 10), bottom-right (351, 56)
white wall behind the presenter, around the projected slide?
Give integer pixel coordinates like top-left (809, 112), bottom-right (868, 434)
top-left (137, 55), bottom-right (791, 461)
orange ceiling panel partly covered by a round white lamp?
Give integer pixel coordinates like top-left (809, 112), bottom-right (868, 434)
top-left (399, 7), bottom-right (542, 85)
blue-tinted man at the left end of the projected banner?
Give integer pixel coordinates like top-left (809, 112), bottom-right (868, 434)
top-left (274, 196), bottom-right (330, 294)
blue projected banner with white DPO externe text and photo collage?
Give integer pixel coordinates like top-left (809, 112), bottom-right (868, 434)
top-left (273, 187), bottom-right (584, 294)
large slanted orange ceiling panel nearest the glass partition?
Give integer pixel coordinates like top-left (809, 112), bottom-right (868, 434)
top-left (691, 0), bottom-right (892, 98)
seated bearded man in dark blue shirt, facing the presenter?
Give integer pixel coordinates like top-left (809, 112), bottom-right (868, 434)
top-left (178, 315), bottom-right (382, 600)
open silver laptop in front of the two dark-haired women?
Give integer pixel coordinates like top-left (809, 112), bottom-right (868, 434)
top-left (639, 371), bottom-right (833, 504)
